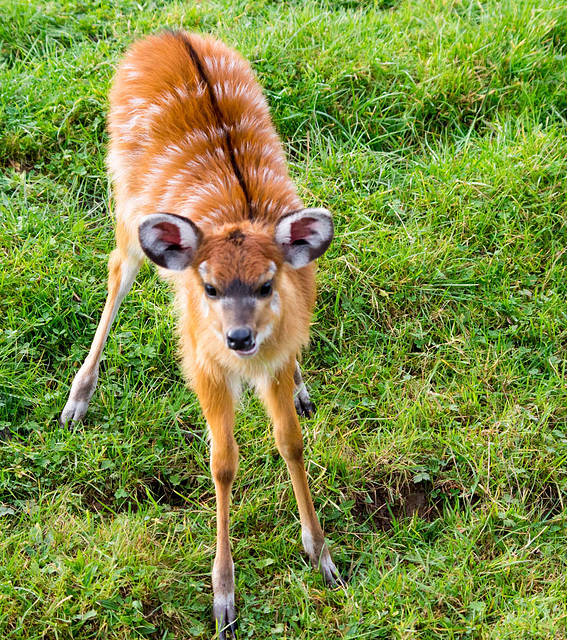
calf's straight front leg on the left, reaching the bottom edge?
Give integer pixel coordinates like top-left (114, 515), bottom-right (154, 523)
top-left (193, 371), bottom-right (238, 640)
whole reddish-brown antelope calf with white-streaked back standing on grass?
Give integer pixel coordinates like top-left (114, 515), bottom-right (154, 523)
top-left (61, 32), bottom-right (342, 637)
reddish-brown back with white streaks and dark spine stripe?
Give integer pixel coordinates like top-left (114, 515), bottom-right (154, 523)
top-left (108, 32), bottom-right (301, 235)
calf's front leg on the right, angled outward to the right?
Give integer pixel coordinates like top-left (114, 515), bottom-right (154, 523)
top-left (260, 361), bottom-right (344, 585)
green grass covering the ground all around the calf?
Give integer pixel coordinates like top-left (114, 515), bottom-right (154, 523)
top-left (0, 0), bottom-right (567, 640)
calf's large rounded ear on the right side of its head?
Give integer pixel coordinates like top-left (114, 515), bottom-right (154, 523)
top-left (275, 209), bottom-right (334, 269)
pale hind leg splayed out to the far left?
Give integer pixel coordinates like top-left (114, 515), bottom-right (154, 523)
top-left (59, 249), bottom-right (143, 425)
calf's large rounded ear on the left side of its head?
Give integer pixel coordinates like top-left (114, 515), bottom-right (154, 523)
top-left (138, 213), bottom-right (202, 271)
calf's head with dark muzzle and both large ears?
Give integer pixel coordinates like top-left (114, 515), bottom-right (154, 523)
top-left (139, 209), bottom-right (333, 357)
